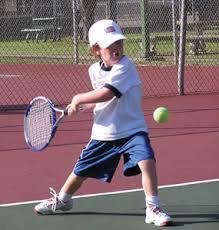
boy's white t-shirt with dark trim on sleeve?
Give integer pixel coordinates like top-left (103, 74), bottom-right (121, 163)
top-left (89, 56), bottom-right (148, 141)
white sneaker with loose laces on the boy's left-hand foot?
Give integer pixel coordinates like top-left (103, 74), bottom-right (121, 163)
top-left (34, 188), bottom-right (73, 215)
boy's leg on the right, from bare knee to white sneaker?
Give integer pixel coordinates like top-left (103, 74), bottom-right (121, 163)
top-left (138, 159), bottom-right (172, 226)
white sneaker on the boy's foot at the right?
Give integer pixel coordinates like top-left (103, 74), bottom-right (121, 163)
top-left (145, 206), bottom-right (172, 226)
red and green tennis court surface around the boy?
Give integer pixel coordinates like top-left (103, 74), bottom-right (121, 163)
top-left (0, 95), bottom-right (219, 230)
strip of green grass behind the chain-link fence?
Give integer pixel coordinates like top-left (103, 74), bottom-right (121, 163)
top-left (0, 32), bottom-right (219, 64)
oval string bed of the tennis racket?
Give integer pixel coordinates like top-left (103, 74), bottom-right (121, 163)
top-left (27, 100), bottom-right (54, 149)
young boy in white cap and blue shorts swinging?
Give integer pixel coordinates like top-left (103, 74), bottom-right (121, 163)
top-left (35, 20), bottom-right (171, 226)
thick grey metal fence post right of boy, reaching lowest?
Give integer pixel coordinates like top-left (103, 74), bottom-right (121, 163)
top-left (178, 0), bottom-right (187, 95)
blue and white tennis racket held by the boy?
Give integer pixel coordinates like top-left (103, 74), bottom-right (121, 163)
top-left (24, 96), bottom-right (68, 151)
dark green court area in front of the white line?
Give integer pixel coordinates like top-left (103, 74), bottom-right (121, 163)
top-left (0, 180), bottom-right (219, 230)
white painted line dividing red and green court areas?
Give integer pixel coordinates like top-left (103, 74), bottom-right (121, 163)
top-left (0, 179), bottom-right (219, 207)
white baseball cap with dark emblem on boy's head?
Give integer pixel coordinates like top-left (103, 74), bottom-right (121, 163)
top-left (88, 19), bottom-right (126, 48)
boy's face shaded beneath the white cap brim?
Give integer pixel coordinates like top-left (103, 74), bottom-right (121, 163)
top-left (99, 40), bottom-right (123, 67)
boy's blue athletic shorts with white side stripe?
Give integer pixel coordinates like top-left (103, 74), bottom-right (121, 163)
top-left (73, 132), bottom-right (154, 182)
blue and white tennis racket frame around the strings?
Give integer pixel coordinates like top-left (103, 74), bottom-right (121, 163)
top-left (24, 96), bottom-right (68, 152)
